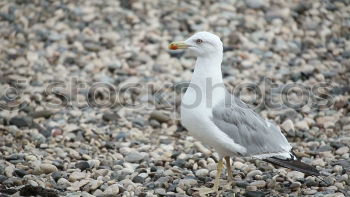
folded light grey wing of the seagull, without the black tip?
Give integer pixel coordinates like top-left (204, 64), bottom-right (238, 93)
top-left (212, 93), bottom-right (291, 156)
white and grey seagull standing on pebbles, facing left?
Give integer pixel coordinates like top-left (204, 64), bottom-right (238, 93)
top-left (169, 32), bottom-right (320, 194)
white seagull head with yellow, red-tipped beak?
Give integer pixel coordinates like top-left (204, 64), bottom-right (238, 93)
top-left (169, 32), bottom-right (223, 56)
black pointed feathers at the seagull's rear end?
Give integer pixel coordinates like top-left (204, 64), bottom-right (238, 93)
top-left (264, 157), bottom-right (321, 176)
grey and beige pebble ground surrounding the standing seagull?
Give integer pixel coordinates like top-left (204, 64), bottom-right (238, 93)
top-left (0, 0), bottom-right (350, 197)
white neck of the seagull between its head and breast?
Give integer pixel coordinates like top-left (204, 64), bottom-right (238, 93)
top-left (191, 53), bottom-right (223, 87)
